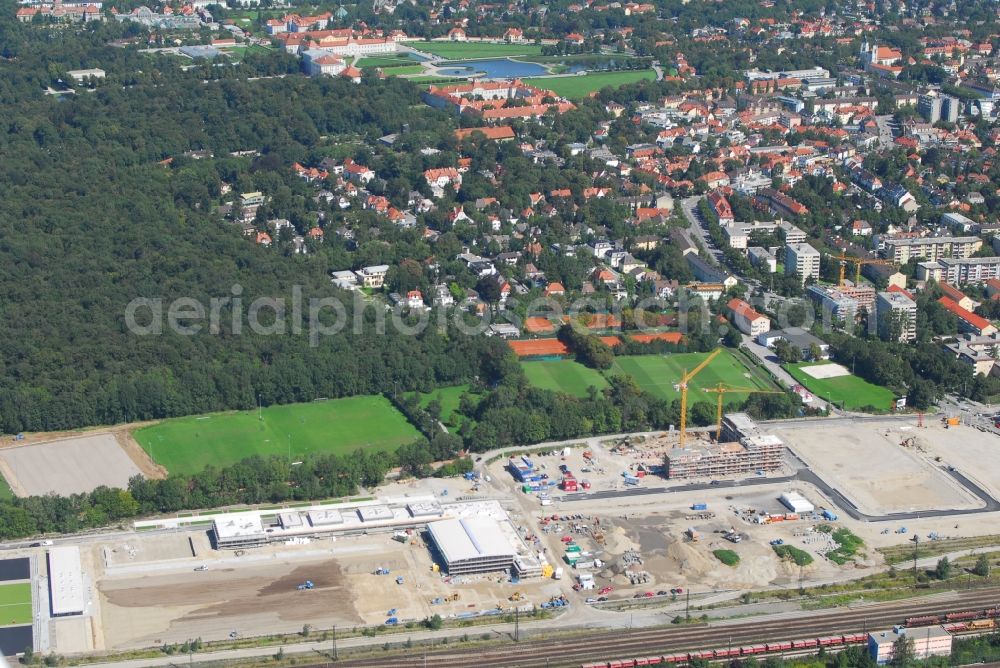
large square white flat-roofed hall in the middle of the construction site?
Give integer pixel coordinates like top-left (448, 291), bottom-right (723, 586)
top-left (427, 517), bottom-right (517, 575)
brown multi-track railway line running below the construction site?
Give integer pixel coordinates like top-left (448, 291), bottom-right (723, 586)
top-left (313, 588), bottom-right (1000, 668)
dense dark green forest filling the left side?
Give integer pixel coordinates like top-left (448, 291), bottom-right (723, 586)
top-left (0, 14), bottom-right (508, 433)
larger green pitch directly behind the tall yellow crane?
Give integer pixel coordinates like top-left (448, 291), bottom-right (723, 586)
top-left (606, 350), bottom-right (776, 404)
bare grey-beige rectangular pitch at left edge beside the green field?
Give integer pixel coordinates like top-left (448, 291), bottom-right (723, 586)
top-left (0, 433), bottom-right (140, 495)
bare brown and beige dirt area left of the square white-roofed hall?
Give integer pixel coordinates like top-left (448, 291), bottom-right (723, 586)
top-left (93, 534), bottom-right (560, 648)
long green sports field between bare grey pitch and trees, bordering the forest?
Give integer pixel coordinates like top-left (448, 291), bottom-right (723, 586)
top-left (134, 395), bottom-right (420, 474)
